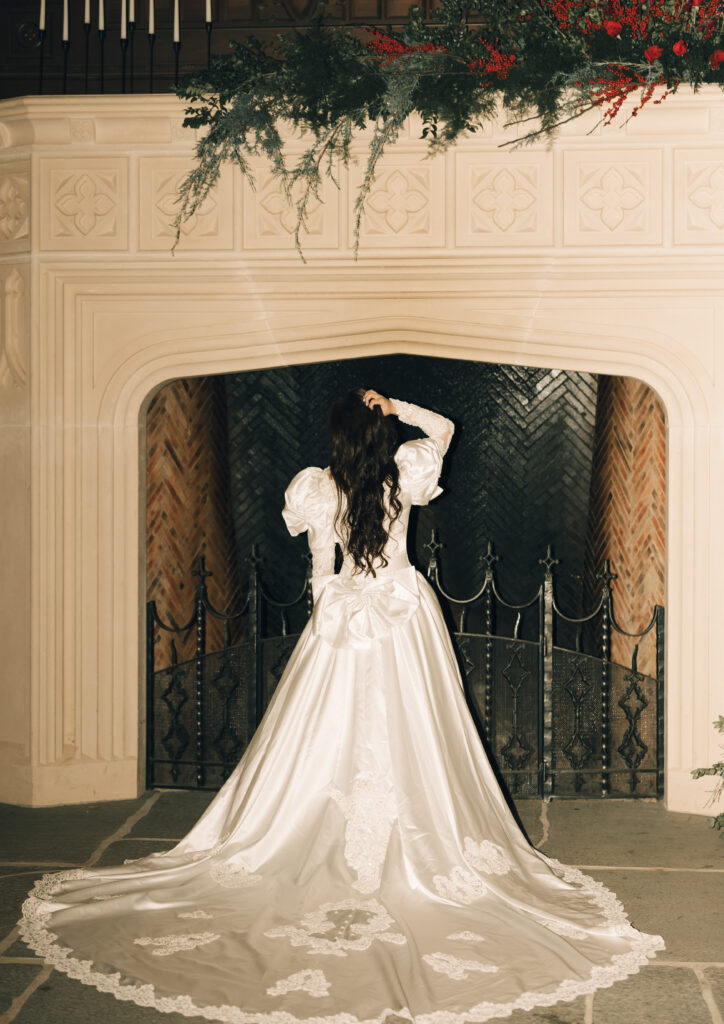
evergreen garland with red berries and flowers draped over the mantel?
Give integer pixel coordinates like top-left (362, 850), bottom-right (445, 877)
top-left (175, 0), bottom-right (724, 258)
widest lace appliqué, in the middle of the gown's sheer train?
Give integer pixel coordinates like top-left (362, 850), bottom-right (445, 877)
top-left (264, 897), bottom-right (408, 956)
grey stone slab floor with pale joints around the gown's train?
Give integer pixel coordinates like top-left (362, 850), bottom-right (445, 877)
top-left (0, 790), bottom-right (724, 1024)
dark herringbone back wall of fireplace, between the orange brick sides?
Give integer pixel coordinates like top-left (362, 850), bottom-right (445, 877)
top-left (224, 355), bottom-right (597, 610)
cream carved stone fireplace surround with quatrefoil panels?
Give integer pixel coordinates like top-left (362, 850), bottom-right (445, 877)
top-left (0, 87), bottom-right (724, 813)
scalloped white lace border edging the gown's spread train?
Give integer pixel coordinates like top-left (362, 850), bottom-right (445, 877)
top-left (17, 864), bottom-right (665, 1024)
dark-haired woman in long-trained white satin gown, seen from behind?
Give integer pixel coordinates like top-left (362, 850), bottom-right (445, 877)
top-left (18, 391), bottom-right (664, 1024)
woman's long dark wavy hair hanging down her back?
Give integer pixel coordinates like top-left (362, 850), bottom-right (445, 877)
top-left (329, 388), bottom-right (402, 575)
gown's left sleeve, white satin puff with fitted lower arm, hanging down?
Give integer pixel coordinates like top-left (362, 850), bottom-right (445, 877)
top-left (282, 466), bottom-right (335, 577)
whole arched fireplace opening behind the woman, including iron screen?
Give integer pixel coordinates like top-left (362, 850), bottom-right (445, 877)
top-left (146, 354), bottom-right (666, 799)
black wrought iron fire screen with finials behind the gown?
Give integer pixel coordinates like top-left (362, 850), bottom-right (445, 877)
top-left (146, 530), bottom-right (665, 797)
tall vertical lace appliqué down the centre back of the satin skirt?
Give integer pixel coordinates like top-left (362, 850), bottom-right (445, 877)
top-left (332, 773), bottom-right (397, 893)
